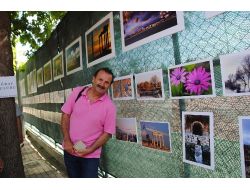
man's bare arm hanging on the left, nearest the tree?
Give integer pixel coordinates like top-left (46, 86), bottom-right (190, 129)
top-left (61, 113), bottom-right (74, 153)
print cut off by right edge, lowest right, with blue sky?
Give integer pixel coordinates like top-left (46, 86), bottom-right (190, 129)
top-left (239, 116), bottom-right (250, 178)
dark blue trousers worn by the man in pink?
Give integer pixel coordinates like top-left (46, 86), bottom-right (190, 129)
top-left (64, 151), bottom-right (99, 178)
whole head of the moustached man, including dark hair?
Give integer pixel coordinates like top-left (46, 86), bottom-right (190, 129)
top-left (92, 67), bottom-right (114, 94)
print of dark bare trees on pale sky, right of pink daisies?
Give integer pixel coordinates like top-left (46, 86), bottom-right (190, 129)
top-left (220, 50), bottom-right (250, 96)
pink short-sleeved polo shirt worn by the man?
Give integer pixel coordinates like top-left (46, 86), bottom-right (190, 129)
top-left (61, 87), bottom-right (116, 158)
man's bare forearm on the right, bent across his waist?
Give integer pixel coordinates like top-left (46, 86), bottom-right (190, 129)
top-left (76, 132), bottom-right (111, 156)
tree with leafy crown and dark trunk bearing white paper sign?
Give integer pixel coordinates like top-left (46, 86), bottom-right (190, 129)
top-left (0, 11), bottom-right (65, 177)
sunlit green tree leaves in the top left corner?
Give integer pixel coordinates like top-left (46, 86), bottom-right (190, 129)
top-left (11, 11), bottom-right (65, 57)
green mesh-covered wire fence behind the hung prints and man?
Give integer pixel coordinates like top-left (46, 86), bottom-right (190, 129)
top-left (17, 12), bottom-right (250, 178)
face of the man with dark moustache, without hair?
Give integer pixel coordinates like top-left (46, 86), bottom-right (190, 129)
top-left (92, 70), bottom-right (112, 94)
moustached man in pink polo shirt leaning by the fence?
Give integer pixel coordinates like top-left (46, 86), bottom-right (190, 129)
top-left (61, 68), bottom-right (116, 178)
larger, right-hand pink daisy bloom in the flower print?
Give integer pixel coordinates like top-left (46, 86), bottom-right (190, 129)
top-left (185, 66), bottom-right (212, 95)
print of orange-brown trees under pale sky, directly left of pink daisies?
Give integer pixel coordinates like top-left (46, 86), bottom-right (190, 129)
top-left (135, 69), bottom-right (165, 100)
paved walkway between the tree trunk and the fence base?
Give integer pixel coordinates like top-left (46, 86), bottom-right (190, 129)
top-left (22, 138), bottom-right (67, 178)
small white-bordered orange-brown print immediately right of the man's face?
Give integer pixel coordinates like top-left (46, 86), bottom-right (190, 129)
top-left (111, 75), bottom-right (135, 100)
